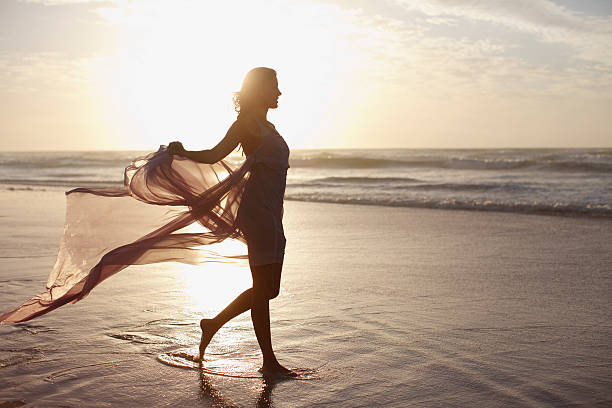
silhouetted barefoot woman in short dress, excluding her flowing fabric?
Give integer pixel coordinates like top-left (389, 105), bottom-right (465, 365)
top-left (168, 68), bottom-right (292, 375)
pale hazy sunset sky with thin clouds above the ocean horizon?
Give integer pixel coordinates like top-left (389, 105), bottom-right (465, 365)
top-left (0, 0), bottom-right (612, 151)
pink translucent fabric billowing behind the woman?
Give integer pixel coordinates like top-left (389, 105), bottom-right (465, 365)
top-left (0, 146), bottom-right (255, 323)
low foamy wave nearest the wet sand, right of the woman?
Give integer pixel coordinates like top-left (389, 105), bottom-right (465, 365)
top-left (285, 193), bottom-right (612, 218)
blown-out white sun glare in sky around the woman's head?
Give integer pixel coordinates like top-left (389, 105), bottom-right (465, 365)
top-left (92, 1), bottom-right (368, 149)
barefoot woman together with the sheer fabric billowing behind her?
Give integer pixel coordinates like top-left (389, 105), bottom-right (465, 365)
top-left (0, 68), bottom-right (293, 375)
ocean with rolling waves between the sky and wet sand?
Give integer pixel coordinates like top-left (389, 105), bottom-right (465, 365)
top-left (0, 149), bottom-right (612, 217)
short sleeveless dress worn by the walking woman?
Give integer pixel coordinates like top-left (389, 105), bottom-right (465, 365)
top-left (237, 121), bottom-right (289, 266)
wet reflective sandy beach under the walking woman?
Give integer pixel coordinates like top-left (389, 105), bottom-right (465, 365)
top-left (0, 191), bottom-right (612, 407)
